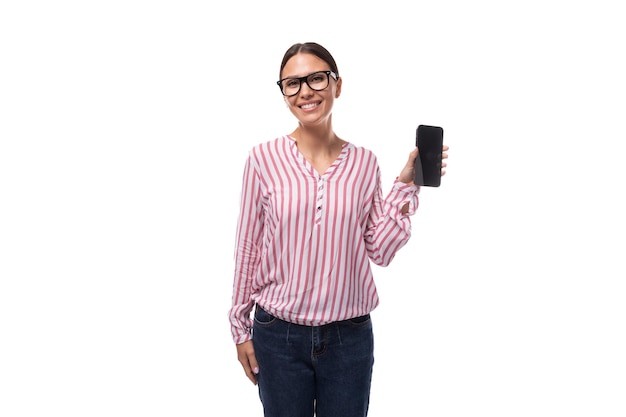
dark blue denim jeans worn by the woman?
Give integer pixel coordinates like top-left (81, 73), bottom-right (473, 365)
top-left (252, 306), bottom-right (374, 417)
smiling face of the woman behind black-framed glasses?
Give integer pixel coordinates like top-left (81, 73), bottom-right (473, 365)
top-left (281, 53), bottom-right (341, 126)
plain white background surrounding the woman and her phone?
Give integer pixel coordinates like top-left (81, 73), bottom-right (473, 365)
top-left (0, 0), bottom-right (626, 417)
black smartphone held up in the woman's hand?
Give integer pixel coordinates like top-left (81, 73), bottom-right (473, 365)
top-left (413, 125), bottom-right (443, 187)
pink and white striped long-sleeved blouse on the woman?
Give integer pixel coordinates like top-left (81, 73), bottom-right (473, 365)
top-left (229, 136), bottom-right (419, 343)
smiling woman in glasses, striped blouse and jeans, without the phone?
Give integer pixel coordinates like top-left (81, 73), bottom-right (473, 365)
top-left (229, 42), bottom-right (448, 417)
